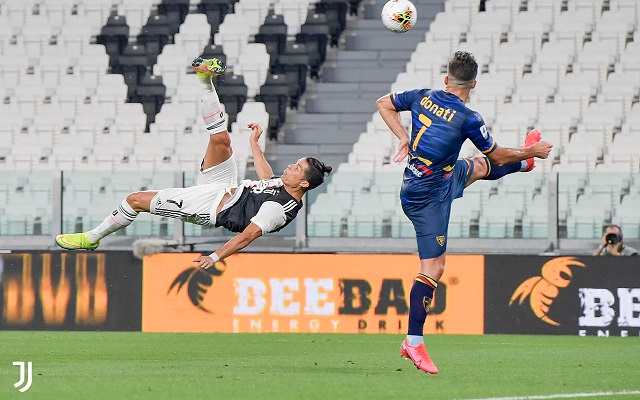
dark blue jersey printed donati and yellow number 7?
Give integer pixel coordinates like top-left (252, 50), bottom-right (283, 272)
top-left (391, 89), bottom-right (496, 183)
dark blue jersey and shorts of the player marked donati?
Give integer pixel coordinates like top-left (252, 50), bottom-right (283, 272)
top-left (391, 89), bottom-right (496, 259)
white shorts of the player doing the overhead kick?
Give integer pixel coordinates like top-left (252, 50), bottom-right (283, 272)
top-left (149, 156), bottom-right (238, 226)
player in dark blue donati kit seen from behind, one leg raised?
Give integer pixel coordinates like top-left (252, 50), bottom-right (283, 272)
top-left (376, 51), bottom-right (552, 374)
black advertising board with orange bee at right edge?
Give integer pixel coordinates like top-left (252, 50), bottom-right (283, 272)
top-left (485, 256), bottom-right (640, 336)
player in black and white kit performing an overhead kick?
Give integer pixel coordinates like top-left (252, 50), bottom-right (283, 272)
top-left (56, 57), bottom-right (331, 268)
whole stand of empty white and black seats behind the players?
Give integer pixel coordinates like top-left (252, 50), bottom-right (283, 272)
top-left (0, 0), bottom-right (640, 252)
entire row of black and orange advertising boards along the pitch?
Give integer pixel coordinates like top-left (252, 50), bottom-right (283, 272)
top-left (0, 251), bottom-right (640, 337)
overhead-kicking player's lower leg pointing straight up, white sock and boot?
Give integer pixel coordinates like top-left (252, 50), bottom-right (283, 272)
top-left (191, 57), bottom-right (233, 170)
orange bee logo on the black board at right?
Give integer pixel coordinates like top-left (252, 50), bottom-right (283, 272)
top-left (509, 257), bottom-right (585, 326)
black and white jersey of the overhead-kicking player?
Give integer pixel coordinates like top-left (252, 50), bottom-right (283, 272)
top-left (215, 178), bottom-right (302, 234)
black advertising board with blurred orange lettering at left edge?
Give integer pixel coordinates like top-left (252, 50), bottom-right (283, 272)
top-left (0, 251), bottom-right (142, 331)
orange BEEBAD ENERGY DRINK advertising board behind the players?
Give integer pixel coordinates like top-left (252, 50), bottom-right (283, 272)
top-left (142, 253), bottom-right (484, 334)
